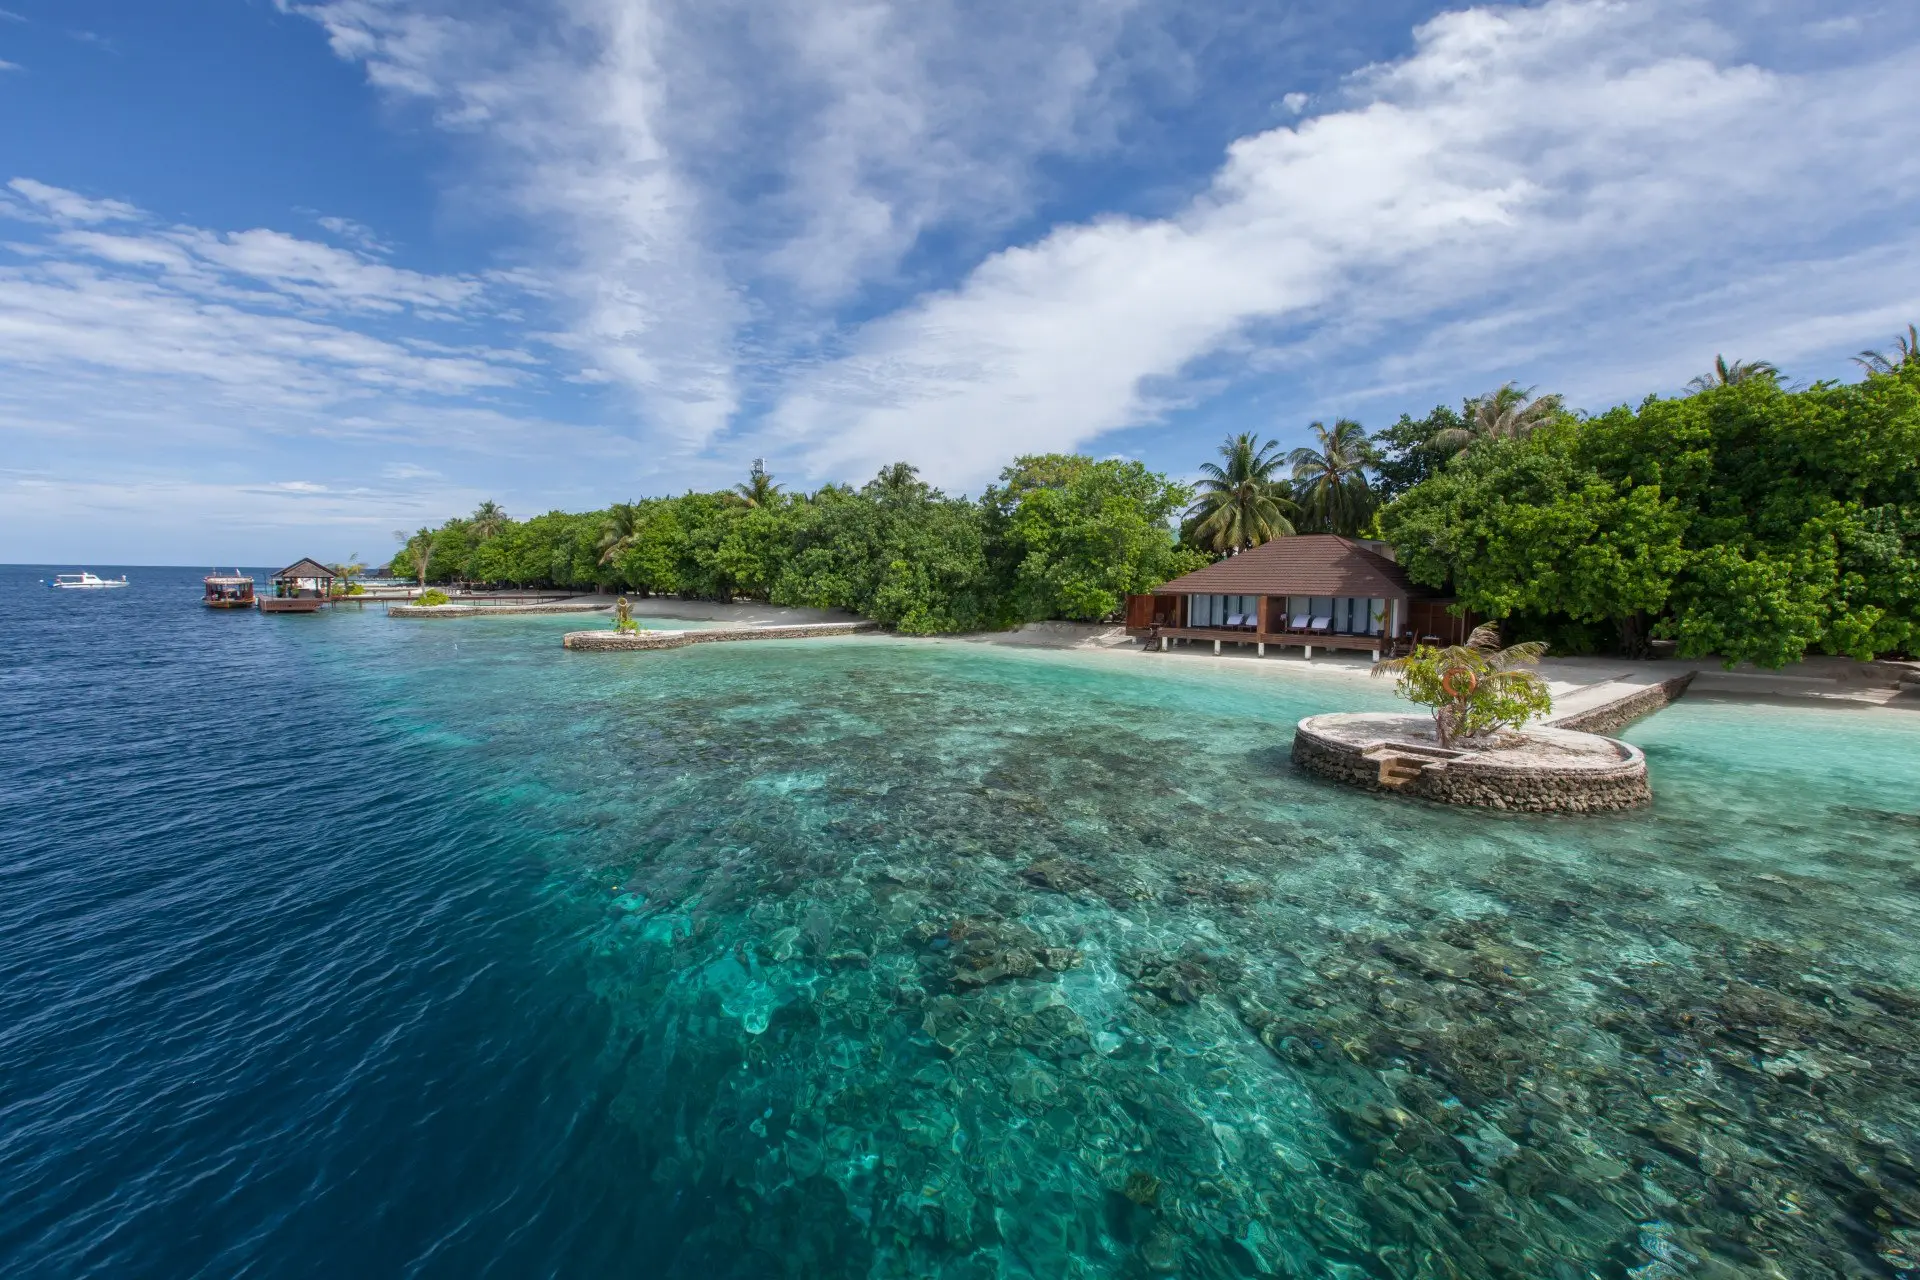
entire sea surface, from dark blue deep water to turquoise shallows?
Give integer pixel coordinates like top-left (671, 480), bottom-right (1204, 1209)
top-left (0, 570), bottom-right (1920, 1278)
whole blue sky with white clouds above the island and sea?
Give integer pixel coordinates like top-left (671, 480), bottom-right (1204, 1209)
top-left (0, 0), bottom-right (1920, 564)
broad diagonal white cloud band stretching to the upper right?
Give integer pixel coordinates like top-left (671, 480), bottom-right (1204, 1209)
top-left (774, 0), bottom-right (1920, 484)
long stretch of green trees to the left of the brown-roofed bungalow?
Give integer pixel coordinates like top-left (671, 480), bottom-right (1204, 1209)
top-left (390, 455), bottom-right (1206, 633)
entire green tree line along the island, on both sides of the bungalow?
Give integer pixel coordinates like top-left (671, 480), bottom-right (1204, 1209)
top-left (392, 330), bottom-right (1920, 666)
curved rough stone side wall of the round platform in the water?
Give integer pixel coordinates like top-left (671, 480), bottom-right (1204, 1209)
top-left (1292, 729), bottom-right (1653, 814)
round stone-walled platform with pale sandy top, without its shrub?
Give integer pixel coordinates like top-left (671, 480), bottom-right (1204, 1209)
top-left (1292, 714), bottom-right (1653, 814)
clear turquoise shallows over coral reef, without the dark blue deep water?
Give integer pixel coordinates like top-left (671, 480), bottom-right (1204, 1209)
top-left (0, 579), bottom-right (1920, 1280)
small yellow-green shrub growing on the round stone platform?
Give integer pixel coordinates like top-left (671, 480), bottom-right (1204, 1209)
top-left (1373, 626), bottom-right (1553, 747)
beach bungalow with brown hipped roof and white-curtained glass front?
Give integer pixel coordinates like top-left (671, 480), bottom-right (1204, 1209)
top-left (1127, 533), bottom-right (1475, 660)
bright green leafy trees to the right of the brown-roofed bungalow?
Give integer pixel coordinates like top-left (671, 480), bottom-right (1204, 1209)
top-left (1380, 359), bottom-right (1920, 666)
